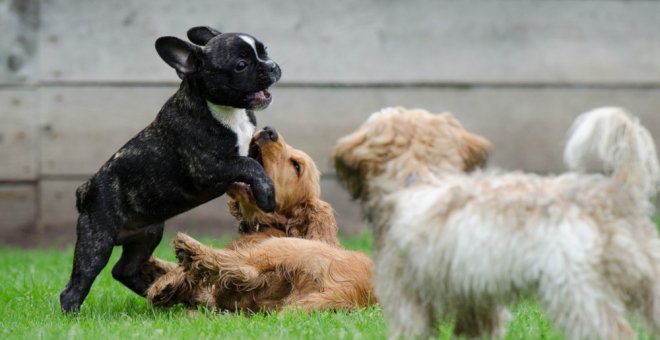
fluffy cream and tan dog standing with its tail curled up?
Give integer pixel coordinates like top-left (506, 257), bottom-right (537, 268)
top-left (333, 108), bottom-right (660, 339)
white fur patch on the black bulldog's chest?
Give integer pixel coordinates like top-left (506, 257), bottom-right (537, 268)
top-left (206, 102), bottom-right (255, 156)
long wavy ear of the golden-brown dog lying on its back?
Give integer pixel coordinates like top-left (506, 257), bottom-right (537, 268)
top-left (286, 200), bottom-right (339, 246)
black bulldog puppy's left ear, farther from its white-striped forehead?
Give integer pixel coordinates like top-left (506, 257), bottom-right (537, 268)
top-left (156, 37), bottom-right (200, 78)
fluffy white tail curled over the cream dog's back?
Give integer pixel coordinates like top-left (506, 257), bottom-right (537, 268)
top-left (564, 107), bottom-right (660, 198)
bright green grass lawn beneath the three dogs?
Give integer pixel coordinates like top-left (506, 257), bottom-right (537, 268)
top-left (0, 227), bottom-right (650, 339)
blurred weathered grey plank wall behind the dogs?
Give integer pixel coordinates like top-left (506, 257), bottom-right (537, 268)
top-left (0, 0), bottom-right (660, 246)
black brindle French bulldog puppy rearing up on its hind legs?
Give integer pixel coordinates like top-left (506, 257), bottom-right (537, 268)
top-left (60, 27), bottom-right (281, 312)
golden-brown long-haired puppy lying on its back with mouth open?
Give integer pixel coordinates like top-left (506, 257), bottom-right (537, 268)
top-left (147, 128), bottom-right (375, 311)
